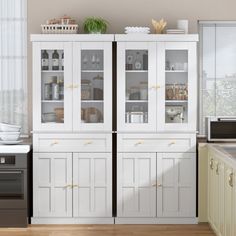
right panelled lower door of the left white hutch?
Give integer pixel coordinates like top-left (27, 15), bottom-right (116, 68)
top-left (73, 153), bottom-right (112, 217)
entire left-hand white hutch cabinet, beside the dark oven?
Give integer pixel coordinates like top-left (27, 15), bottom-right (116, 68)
top-left (31, 35), bottom-right (114, 223)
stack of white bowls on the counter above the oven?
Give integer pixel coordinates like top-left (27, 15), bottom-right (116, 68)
top-left (0, 123), bottom-right (22, 144)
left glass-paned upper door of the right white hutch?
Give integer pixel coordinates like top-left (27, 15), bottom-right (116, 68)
top-left (117, 43), bottom-right (156, 131)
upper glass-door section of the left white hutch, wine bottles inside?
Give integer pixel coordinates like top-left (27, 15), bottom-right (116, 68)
top-left (32, 35), bottom-right (114, 132)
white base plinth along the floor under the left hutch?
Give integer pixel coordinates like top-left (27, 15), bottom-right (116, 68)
top-left (31, 217), bottom-right (115, 224)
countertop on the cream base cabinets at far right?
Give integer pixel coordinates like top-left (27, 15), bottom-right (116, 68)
top-left (207, 143), bottom-right (236, 168)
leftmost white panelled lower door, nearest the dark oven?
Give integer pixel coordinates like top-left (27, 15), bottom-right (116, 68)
top-left (33, 153), bottom-right (72, 217)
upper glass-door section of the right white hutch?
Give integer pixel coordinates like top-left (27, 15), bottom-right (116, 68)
top-left (115, 35), bottom-right (198, 132)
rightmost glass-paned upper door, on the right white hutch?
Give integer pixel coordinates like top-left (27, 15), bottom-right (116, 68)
top-left (159, 43), bottom-right (197, 131)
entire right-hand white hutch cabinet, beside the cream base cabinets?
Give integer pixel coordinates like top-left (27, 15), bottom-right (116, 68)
top-left (115, 35), bottom-right (198, 224)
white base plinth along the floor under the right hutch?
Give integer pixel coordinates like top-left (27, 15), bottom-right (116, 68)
top-left (115, 217), bottom-right (198, 224)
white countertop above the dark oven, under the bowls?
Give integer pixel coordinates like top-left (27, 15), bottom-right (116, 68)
top-left (0, 138), bottom-right (32, 154)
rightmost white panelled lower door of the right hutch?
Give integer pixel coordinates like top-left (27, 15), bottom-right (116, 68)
top-left (157, 153), bottom-right (196, 217)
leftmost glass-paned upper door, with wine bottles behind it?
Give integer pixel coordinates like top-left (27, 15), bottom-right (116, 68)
top-left (34, 43), bottom-right (73, 131)
